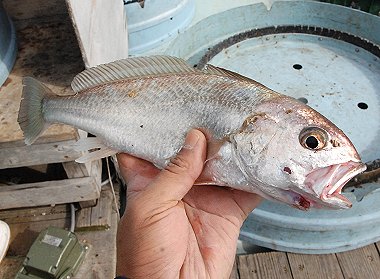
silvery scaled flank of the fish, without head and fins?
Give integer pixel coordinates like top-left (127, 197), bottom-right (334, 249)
top-left (44, 74), bottom-right (274, 166)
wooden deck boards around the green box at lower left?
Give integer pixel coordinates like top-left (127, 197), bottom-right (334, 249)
top-left (0, 185), bottom-right (118, 279)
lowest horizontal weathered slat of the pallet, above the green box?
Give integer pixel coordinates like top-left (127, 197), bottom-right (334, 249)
top-left (0, 177), bottom-right (100, 209)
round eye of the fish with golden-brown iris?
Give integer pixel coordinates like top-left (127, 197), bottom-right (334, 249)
top-left (299, 127), bottom-right (328, 150)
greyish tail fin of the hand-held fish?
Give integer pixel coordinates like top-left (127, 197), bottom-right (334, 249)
top-left (17, 77), bottom-right (54, 145)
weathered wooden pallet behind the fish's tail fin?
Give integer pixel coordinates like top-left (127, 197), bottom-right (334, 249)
top-left (0, 0), bottom-right (101, 209)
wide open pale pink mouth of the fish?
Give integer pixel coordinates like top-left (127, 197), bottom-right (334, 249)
top-left (304, 161), bottom-right (367, 209)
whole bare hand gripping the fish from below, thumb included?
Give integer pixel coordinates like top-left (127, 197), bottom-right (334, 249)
top-left (116, 130), bottom-right (261, 279)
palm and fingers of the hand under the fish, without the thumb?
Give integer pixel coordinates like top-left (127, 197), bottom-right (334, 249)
top-left (118, 154), bottom-right (260, 278)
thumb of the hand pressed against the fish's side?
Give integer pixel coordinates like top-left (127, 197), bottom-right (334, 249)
top-left (146, 129), bottom-right (207, 202)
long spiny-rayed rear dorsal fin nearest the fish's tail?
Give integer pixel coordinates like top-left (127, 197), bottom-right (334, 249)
top-left (71, 55), bottom-right (197, 92)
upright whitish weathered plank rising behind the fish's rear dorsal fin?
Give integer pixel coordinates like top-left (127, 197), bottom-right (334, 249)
top-left (66, 0), bottom-right (128, 67)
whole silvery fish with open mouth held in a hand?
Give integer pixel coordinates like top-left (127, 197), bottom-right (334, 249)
top-left (18, 55), bottom-right (366, 210)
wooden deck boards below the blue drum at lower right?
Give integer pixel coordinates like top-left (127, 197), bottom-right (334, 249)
top-left (230, 242), bottom-right (380, 279)
